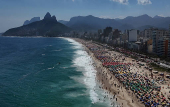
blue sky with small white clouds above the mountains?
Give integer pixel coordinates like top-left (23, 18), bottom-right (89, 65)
top-left (0, 0), bottom-right (170, 33)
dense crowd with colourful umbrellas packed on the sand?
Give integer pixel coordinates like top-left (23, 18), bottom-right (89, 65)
top-left (84, 42), bottom-right (170, 107)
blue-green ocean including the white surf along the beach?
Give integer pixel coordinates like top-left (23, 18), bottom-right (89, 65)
top-left (0, 36), bottom-right (113, 107)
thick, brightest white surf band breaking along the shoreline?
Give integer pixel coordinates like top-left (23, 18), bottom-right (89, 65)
top-left (65, 38), bottom-right (98, 103)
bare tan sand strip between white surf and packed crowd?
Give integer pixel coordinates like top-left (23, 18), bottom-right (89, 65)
top-left (71, 38), bottom-right (144, 107)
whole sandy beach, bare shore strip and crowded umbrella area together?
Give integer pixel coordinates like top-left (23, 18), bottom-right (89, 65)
top-left (74, 38), bottom-right (169, 107)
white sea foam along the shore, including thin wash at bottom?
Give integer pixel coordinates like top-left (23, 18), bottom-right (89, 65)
top-left (61, 38), bottom-right (111, 106)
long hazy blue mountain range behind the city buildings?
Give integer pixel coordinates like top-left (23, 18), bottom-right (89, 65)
top-left (63, 14), bottom-right (170, 31)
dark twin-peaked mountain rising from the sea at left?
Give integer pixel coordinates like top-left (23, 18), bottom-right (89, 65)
top-left (3, 12), bottom-right (71, 36)
